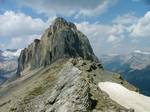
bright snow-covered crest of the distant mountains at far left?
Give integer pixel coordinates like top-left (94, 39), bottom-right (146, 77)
top-left (2, 49), bottom-right (22, 58)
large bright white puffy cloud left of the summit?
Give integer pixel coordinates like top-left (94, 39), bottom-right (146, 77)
top-left (0, 11), bottom-right (46, 38)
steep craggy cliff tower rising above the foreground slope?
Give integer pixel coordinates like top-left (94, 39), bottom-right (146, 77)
top-left (17, 17), bottom-right (98, 74)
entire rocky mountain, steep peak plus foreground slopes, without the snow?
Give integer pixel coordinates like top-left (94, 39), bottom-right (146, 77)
top-left (0, 17), bottom-right (137, 112)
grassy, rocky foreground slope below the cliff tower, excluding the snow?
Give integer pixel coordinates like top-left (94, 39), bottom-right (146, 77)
top-left (0, 59), bottom-right (136, 112)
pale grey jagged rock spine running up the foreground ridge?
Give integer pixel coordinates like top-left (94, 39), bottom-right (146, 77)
top-left (46, 63), bottom-right (92, 112)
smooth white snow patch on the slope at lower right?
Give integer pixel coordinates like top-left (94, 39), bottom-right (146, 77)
top-left (98, 82), bottom-right (150, 112)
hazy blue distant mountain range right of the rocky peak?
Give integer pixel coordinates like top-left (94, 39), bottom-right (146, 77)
top-left (100, 50), bottom-right (150, 96)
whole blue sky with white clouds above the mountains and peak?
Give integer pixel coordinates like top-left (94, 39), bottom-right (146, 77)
top-left (0, 0), bottom-right (150, 55)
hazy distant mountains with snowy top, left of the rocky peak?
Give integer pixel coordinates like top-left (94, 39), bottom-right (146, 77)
top-left (0, 49), bottom-right (21, 85)
